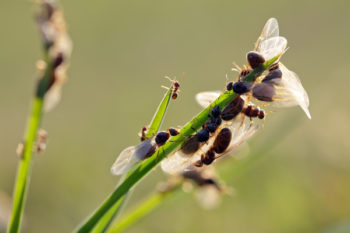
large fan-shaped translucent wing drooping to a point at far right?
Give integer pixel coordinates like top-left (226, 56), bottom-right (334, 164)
top-left (272, 63), bottom-right (311, 119)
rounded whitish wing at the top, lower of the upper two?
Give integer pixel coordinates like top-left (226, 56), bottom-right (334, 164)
top-left (256, 36), bottom-right (287, 60)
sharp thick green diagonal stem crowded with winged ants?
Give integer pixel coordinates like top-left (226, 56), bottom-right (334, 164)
top-left (76, 55), bottom-right (280, 233)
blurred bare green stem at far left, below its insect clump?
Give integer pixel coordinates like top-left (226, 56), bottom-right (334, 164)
top-left (8, 97), bottom-right (43, 233)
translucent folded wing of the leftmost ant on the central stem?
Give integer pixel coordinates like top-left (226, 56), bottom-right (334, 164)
top-left (111, 139), bottom-right (154, 175)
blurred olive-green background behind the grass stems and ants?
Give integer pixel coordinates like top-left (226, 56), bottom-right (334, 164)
top-left (0, 0), bottom-right (350, 233)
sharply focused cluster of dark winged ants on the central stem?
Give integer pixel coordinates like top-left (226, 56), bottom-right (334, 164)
top-left (112, 18), bottom-right (311, 177)
